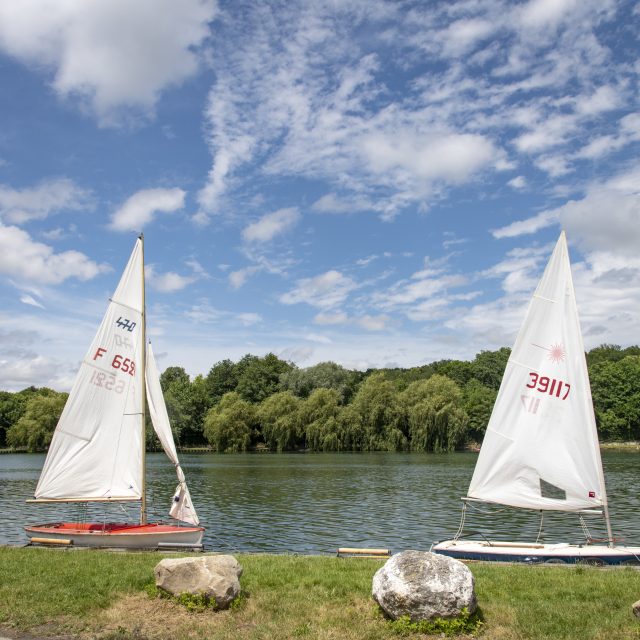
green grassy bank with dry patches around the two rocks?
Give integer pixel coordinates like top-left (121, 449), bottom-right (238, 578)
top-left (0, 547), bottom-right (640, 640)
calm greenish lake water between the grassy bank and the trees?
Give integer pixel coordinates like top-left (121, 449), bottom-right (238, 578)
top-left (0, 452), bottom-right (640, 554)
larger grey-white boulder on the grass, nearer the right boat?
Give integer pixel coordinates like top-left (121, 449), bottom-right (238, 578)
top-left (372, 551), bottom-right (477, 622)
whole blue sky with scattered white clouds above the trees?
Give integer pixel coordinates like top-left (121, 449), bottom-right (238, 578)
top-left (0, 0), bottom-right (640, 391)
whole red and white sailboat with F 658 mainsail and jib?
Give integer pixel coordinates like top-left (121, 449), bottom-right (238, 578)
top-left (25, 235), bottom-right (204, 548)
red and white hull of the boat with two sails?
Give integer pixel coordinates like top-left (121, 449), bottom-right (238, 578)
top-left (25, 522), bottom-right (204, 549)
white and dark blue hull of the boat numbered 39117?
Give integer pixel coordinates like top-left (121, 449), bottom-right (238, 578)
top-left (431, 540), bottom-right (640, 565)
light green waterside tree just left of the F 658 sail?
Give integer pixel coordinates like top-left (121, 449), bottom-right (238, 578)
top-left (7, 388), bottom-right (68, 451)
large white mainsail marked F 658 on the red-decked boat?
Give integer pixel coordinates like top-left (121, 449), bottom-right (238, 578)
top-left (35, 240), bottom-right (143, 500)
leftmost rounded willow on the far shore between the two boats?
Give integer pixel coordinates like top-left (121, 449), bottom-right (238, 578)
top-left (204, 391), bottom-right (256, 453)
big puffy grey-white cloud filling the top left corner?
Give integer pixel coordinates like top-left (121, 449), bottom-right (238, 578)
top-left (0, 0), bottom-right (216, 125)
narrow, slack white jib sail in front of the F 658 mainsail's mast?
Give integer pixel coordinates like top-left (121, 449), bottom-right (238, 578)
top-left (145, 343), bottom-right (200, 525)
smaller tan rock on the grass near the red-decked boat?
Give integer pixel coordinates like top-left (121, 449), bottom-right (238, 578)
top-left (153, 556), bottom-right (242, 609)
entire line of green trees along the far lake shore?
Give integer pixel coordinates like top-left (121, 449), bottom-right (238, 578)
top-left (0, 345), bottom-right (640, 452)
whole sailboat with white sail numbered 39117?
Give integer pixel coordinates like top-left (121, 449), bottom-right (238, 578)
top-left (432, 231), bottom-right (640, 564)
